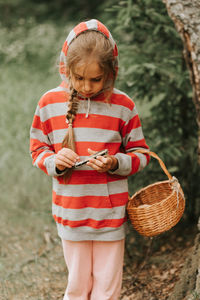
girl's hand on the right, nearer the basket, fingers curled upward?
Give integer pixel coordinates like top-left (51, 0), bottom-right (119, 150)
top-left (87, 149), bottom-right (118, 173)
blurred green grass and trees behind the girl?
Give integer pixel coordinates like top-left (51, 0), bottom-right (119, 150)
top-left (0, 0), bottom-right (200, 300)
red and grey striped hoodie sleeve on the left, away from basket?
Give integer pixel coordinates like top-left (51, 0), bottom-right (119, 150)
top-left (30, 105), bottom-right (63, 176)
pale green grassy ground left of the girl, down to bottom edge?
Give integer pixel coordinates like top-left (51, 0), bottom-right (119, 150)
top-left (0, 65), bottom-right (67, 300)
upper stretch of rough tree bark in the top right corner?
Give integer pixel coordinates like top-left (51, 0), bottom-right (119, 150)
top-left (163, 0), bottom-right (200, 165)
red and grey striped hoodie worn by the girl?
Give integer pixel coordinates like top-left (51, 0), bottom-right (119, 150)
top-left (30, 20), bottom-right (149, 241)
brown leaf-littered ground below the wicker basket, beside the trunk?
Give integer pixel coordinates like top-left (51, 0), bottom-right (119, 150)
top-left (121, 220), bottom-right (198, 300)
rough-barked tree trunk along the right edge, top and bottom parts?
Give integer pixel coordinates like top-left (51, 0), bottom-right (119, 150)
top-left (163, 0), bottom-right (200, 300)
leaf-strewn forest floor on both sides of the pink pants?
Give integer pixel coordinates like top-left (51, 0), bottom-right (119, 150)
top-left (0, 213), bottom-right (197, 300)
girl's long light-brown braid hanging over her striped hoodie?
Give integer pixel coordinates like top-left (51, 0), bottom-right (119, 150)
top-left (62, 84), bottom-right (79, 152)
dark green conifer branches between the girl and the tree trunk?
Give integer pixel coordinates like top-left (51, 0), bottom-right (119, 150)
top-left (102, 0), bottom-right (200, 218)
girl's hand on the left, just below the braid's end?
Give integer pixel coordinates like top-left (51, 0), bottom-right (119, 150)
top-left (55, 148), bottom-right (80, 171)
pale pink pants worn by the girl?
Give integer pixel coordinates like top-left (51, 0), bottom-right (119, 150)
top-left (62, 240), bottom-right (124, 300)
